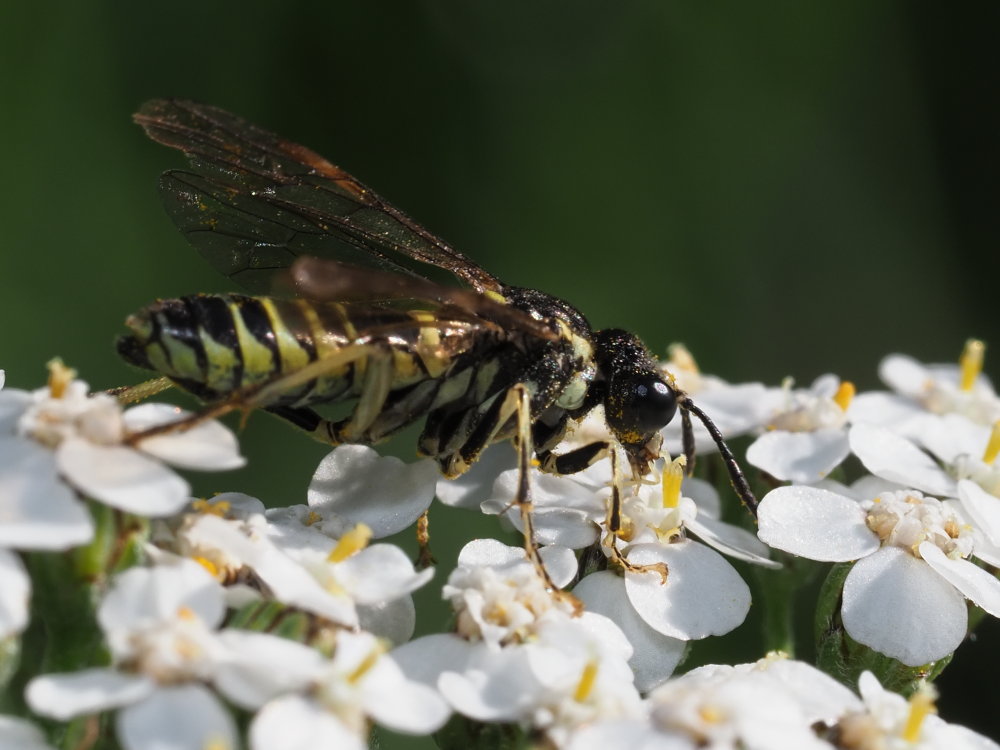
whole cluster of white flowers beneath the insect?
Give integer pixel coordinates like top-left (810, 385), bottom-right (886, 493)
top-left (0, 342), bottom-right (1000, 750)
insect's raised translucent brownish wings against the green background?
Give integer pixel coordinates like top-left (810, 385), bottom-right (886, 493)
top-left (135, 99), bottom-right (501, 292)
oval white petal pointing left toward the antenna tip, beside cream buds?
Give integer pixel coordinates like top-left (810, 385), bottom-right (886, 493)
top-left (757, 486), bottom-right (879, 562)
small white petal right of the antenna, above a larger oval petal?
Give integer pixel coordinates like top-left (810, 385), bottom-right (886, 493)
top-left (747, 428), bottom-right (850, 484)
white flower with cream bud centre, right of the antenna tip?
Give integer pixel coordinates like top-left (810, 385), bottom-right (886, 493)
top-left (758, 486), bottom-right (1000, 666)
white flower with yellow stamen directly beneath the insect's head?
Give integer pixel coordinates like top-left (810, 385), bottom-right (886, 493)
top-left (484, 459), bottom-right (776, 690)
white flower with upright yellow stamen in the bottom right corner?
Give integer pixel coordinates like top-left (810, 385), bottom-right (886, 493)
top-left (835, 672), bottom-right (1000, 750)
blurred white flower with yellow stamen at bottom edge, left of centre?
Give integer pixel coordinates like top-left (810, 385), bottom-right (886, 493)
top-left (250, 631), bottom-right (450, 750)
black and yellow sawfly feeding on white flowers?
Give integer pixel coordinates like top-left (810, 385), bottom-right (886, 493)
top-left (118, 100), bottom-right (756, 579)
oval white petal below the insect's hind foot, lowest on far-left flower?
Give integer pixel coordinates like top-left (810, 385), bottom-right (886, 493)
top-left (56, 438), bottom-right (191, 518)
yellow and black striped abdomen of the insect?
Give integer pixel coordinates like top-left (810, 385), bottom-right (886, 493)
top-left (118, 295), bottom-right (481, 406)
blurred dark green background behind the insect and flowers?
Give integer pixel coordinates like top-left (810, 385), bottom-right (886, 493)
top-left (0, 0), bottom-right (1000, 734)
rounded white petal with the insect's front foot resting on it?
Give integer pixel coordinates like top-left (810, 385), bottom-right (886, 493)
top-left (625, 540), bottom-right (750, 640)
